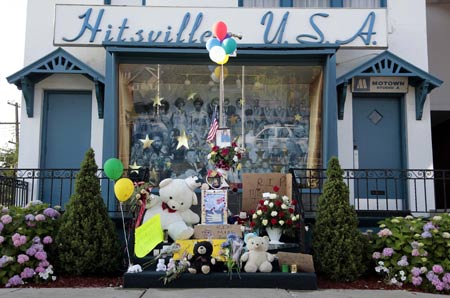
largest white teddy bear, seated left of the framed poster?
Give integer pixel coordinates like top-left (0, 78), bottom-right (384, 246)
top-left (143, 176), bottom-right (201, 240)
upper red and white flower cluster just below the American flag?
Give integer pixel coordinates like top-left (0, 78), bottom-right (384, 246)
top-left (208, 141), bottom-right (245, 171)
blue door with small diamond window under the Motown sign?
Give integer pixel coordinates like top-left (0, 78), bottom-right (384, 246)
top-left (353, 97), bottom-right (405, 206)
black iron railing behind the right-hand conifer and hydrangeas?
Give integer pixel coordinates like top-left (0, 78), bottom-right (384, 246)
top-left (289, 168), bottom-right (450, 215)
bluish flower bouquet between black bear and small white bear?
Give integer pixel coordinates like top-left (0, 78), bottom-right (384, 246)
top-left (219, 233), bottom-right (244, 279)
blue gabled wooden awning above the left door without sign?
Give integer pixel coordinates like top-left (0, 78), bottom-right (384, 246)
top-left (6, 48), bottom-right (105, 118)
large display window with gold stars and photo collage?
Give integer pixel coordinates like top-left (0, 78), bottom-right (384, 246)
top-left (118, 64), bottom-right (323, 183)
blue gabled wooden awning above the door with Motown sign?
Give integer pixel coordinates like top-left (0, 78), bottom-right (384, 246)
top-left (336, 51), bottom-right (443, 120)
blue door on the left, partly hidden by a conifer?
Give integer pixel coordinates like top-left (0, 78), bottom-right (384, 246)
top-left (40, 91), bottom-right (92, 206)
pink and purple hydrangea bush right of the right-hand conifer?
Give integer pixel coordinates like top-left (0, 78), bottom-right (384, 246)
top-left (372, 214), bottom-right (450, 293)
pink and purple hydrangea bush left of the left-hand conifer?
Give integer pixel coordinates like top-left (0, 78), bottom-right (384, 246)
top-left (0, 201), bottom-right (60, 287)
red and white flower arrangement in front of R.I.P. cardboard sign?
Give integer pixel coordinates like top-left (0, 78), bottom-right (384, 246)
top-left (250, 186), bottom-right (300, 236)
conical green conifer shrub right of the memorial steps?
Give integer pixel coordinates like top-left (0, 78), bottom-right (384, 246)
top-left (313, 157), bottom-right (366, 281)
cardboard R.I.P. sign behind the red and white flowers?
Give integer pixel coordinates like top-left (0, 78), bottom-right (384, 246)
top-left (241, 173), bottom-right (292, 211)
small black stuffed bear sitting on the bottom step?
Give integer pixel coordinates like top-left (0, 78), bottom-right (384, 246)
top-left (188, 241), bottom-right (216, 274)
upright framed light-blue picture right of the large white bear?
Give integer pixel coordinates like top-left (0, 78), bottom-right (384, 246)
top-left (201, 189), bottom-right (228, 225)
